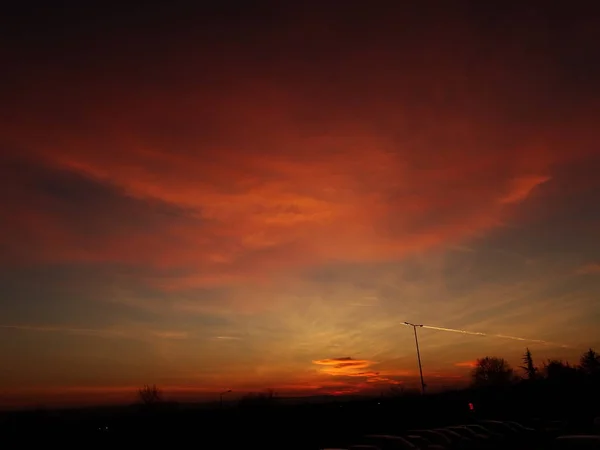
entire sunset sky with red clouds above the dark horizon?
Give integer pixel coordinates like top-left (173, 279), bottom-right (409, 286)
top-left (0, 1), bottom-right (600, 408)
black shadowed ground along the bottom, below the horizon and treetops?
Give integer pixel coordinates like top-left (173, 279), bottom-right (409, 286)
top-left (0, 391), bottom-right (600, 450)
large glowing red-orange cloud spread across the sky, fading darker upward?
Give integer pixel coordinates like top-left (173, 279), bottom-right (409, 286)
top-left (1, 8), bottom-right (593, 298)
